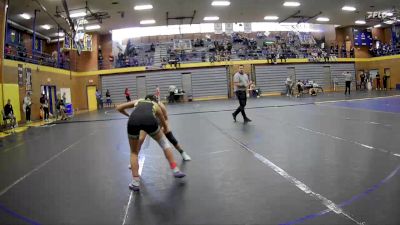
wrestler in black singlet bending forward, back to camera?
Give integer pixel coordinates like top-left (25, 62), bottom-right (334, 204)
top-left (117, 99), bottom-right (186, 191)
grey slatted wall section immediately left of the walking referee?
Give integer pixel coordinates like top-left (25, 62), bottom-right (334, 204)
top-left (190, 67), bottom-right (228, 98)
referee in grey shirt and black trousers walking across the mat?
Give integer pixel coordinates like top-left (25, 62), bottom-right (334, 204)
top-left (232, 65), bottom-right (251, 123)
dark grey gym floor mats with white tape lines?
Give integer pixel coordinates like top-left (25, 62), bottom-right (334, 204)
top-left (0, 92), bottom-right (400, 225)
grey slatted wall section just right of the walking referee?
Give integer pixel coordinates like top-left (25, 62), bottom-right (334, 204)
top-left (256, 65), bottom-right (293, 93)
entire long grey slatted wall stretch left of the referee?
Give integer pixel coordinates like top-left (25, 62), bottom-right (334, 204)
top-left (101, 67), bottom-right (228, 103)
